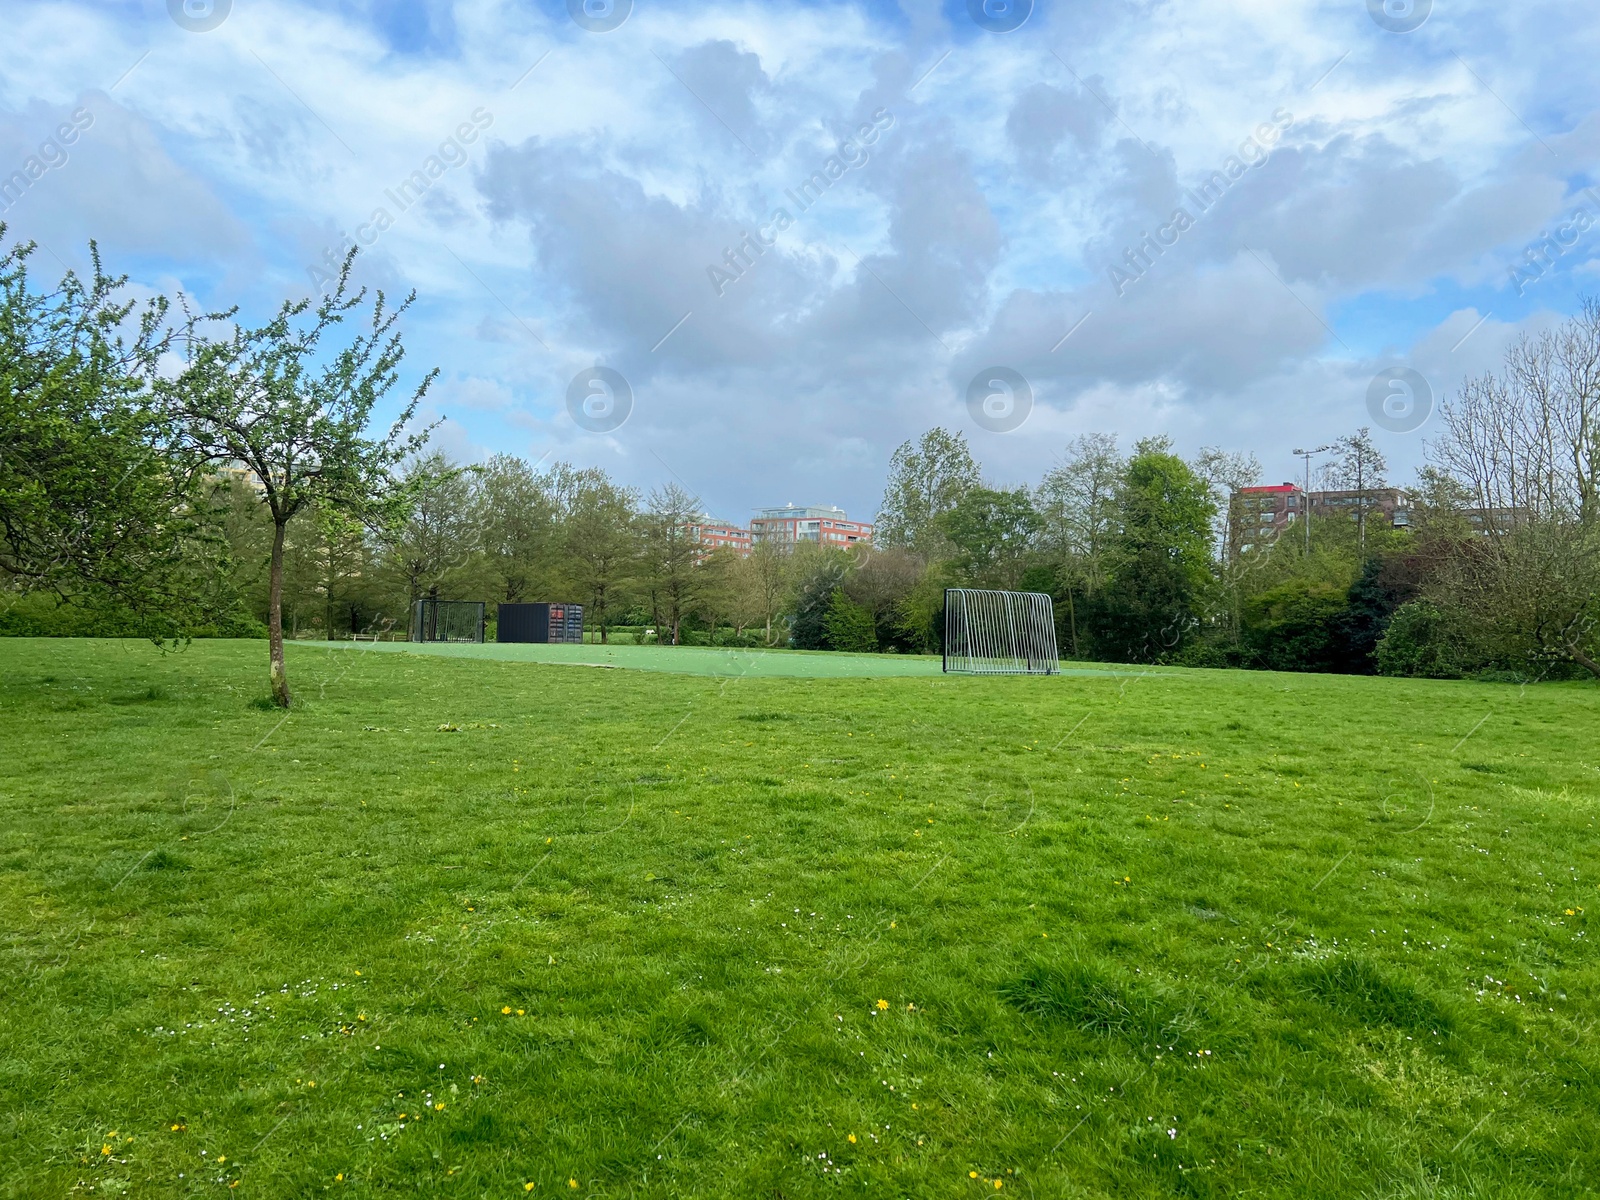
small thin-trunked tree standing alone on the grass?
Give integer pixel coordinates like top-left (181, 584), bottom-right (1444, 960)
top-left (166, 250), bottom-right (438, 709)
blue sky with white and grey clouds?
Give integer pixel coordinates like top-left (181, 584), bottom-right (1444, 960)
top-left (0, 0), bottom-right (1600, 518)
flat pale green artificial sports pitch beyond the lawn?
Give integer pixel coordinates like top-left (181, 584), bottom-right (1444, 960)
top-left (286, 642), bottom-right (1145, 678)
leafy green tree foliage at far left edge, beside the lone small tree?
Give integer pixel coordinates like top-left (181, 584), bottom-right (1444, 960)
top-left (0, 224), bottom-right (226, 635)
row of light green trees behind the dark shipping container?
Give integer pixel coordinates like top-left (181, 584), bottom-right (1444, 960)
top-left (227, 453), bottom-right (794, 645)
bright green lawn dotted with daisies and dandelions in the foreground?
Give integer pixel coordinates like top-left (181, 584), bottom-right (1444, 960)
top-left (0, 640), bottom-right (1600, 1200)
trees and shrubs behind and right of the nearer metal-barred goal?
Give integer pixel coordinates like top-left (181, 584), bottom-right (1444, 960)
top-left (835, 301), bottom-right (1600, 678)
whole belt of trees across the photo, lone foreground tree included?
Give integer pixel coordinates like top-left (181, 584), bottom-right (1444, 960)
top-left (9, 227), bottom-right (1600, 691)
